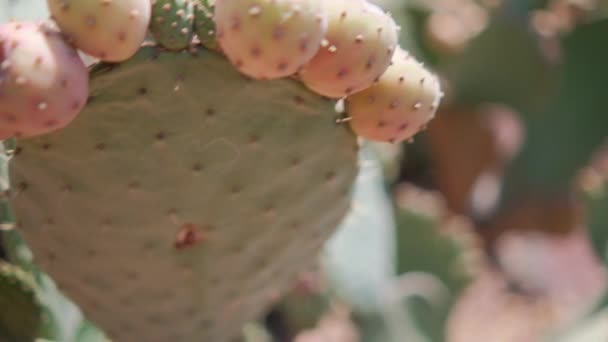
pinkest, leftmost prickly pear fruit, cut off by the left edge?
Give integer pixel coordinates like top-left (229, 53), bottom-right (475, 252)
top-left (0, 22), bottom-right (89, 139)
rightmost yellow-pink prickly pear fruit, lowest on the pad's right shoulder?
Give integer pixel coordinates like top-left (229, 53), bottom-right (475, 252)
top-left (346, 49), bottom-right (442, 143)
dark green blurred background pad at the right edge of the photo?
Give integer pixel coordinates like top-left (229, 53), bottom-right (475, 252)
top-left (505, 20), bottom-right (608, 198)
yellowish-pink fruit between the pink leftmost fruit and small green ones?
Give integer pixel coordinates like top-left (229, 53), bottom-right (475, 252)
top-left (47, 0), bottom-right (152, 62)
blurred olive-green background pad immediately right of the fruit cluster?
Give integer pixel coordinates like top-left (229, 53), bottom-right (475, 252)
top-left (439, 16), bottom-right (559, 111)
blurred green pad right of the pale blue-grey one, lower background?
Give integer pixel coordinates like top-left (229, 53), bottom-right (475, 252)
top-left (397, 189), bottom-right (480, 342)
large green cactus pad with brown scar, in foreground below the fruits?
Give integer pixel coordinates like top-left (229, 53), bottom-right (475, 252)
top-left (10, 47), bottom-right (357, 342)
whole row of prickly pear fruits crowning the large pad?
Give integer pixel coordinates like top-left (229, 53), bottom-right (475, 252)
top-left (0, 0), bottom-right (442, 143)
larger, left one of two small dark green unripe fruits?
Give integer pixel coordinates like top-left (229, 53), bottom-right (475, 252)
top-left (150, 0), bottom-right (194, 50)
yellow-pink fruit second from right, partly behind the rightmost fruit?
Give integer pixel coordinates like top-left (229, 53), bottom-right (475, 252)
top-left (299, 0), bottom-right (398, 98)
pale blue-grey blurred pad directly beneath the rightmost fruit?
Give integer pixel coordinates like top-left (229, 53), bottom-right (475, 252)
top-left (322, 143), bottom-right (396, 312)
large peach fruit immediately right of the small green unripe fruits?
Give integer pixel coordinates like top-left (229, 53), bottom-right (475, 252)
top-left (214, 0), bottom-right (327, 79)
